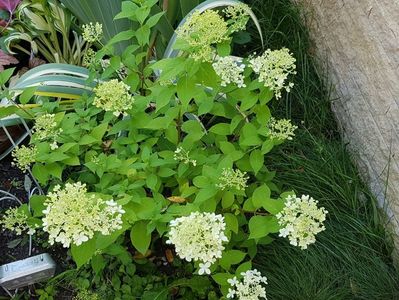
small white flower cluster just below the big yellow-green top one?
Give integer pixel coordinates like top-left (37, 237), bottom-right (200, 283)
top-left (212, 56), bottom-right (246, 88)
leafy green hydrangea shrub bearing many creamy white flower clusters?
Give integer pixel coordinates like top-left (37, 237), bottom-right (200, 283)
top-left (3, 0), bottom-right (327, 299)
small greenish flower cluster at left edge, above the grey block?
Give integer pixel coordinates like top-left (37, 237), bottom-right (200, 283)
top-left (0, 207), bottom-right (35, 235)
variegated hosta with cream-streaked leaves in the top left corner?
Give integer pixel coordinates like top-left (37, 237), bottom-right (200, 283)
top-left (2, 0), bottom-right (96, 65)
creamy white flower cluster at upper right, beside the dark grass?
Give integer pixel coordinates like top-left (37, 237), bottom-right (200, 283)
top-left (250, 48), bottom-right (296, 99)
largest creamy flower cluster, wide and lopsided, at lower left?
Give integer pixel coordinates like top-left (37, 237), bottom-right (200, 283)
top-left (43, 182), bottom-right (125, 248)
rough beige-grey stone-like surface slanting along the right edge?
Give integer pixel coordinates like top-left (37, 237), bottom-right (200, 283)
top-left (296, 0), bottom-right (399, 250)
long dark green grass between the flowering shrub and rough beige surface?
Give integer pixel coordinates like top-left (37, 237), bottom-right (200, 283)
top-left (247, 0), bottom-right (399, 300)
